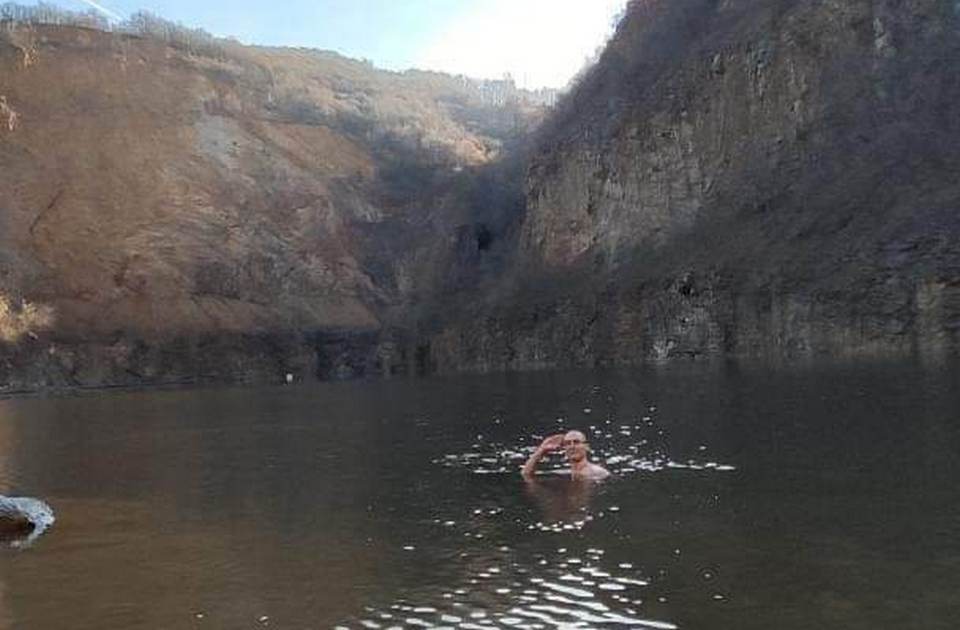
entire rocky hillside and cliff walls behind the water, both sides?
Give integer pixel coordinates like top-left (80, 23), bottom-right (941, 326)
top-left (0, 0), bottom-right (960, 391)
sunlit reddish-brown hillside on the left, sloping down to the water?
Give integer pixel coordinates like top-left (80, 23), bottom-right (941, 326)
top-left (0, 23), bottom-right (542, 388)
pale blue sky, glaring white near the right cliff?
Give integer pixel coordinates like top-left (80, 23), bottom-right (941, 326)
top-left (43, 0), bottom-right (626, 89)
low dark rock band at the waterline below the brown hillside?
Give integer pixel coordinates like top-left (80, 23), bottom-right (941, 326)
top-left (0, 330), bottom-right (430, 395)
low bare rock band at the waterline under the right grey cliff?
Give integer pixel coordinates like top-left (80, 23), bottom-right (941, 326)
top-left (429, 275), bottom-right (960, 372)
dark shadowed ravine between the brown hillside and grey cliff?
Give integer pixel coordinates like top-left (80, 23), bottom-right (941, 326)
top-left (363, 129), bottom-right (531, 332)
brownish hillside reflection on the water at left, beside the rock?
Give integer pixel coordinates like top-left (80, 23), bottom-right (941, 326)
top-left (0, 389), bottom-right (394, 630)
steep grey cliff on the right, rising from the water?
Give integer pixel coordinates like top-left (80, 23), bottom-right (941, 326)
top-left (433, 0), bottom-right (960, 370)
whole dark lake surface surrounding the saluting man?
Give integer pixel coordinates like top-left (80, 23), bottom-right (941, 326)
top-left (0, 364), bottom-right (960, 630)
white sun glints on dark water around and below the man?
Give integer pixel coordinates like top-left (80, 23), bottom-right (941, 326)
top-left (343, 406), bottom-right (734, 630)
